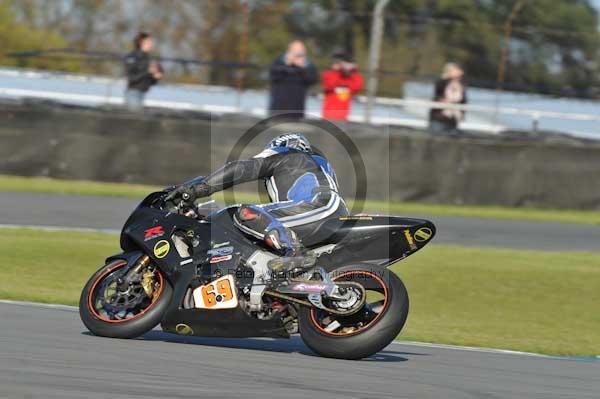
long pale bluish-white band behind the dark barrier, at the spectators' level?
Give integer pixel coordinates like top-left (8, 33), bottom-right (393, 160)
top-left (0, 68), bottom-right (600, 139)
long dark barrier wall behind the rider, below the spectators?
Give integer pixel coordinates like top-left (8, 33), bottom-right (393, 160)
top-left (0, 103), bottom-right (600, 209)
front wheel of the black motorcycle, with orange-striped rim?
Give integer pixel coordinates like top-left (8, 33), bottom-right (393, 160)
top-left (79, 260), bottom-right (173, 338)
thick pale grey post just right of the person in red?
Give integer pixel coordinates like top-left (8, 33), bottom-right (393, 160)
top-left (365, 0), bottom-right (390, 123)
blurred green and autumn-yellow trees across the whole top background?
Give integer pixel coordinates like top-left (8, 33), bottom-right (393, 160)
top-left (0, 0), bottom-right (600, 96)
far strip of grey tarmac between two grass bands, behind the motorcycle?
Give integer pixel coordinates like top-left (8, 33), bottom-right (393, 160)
top-left (0, 192), bottom-right (600, 252)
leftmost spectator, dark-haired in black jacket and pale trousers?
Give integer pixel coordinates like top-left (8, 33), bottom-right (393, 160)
top-left (125, 32), bottom-right (163, 109)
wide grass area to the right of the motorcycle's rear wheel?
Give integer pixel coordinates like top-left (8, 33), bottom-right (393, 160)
top-left (392, 245), bottom-right (600, 355)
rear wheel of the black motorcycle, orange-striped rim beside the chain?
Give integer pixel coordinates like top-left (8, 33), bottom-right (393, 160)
top-left (298, 265), bottom-right (408, 360)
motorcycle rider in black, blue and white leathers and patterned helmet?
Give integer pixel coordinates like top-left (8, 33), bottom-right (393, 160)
top-left (170, 133), bottom-right (348, 271)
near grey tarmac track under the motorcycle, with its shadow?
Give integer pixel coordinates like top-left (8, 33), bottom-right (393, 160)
top-left (0, 303), bottom-right (600, 399)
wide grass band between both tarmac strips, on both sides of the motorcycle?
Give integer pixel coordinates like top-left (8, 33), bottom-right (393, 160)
top-left (0, 229), bottom-right (600, 355)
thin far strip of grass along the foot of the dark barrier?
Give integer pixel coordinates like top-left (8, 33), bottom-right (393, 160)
top-left (0, 175), bottom-right (600, 225)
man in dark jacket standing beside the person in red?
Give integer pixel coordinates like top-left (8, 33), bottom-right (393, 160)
top-left (269, 40), bottom-right (318, 118)
